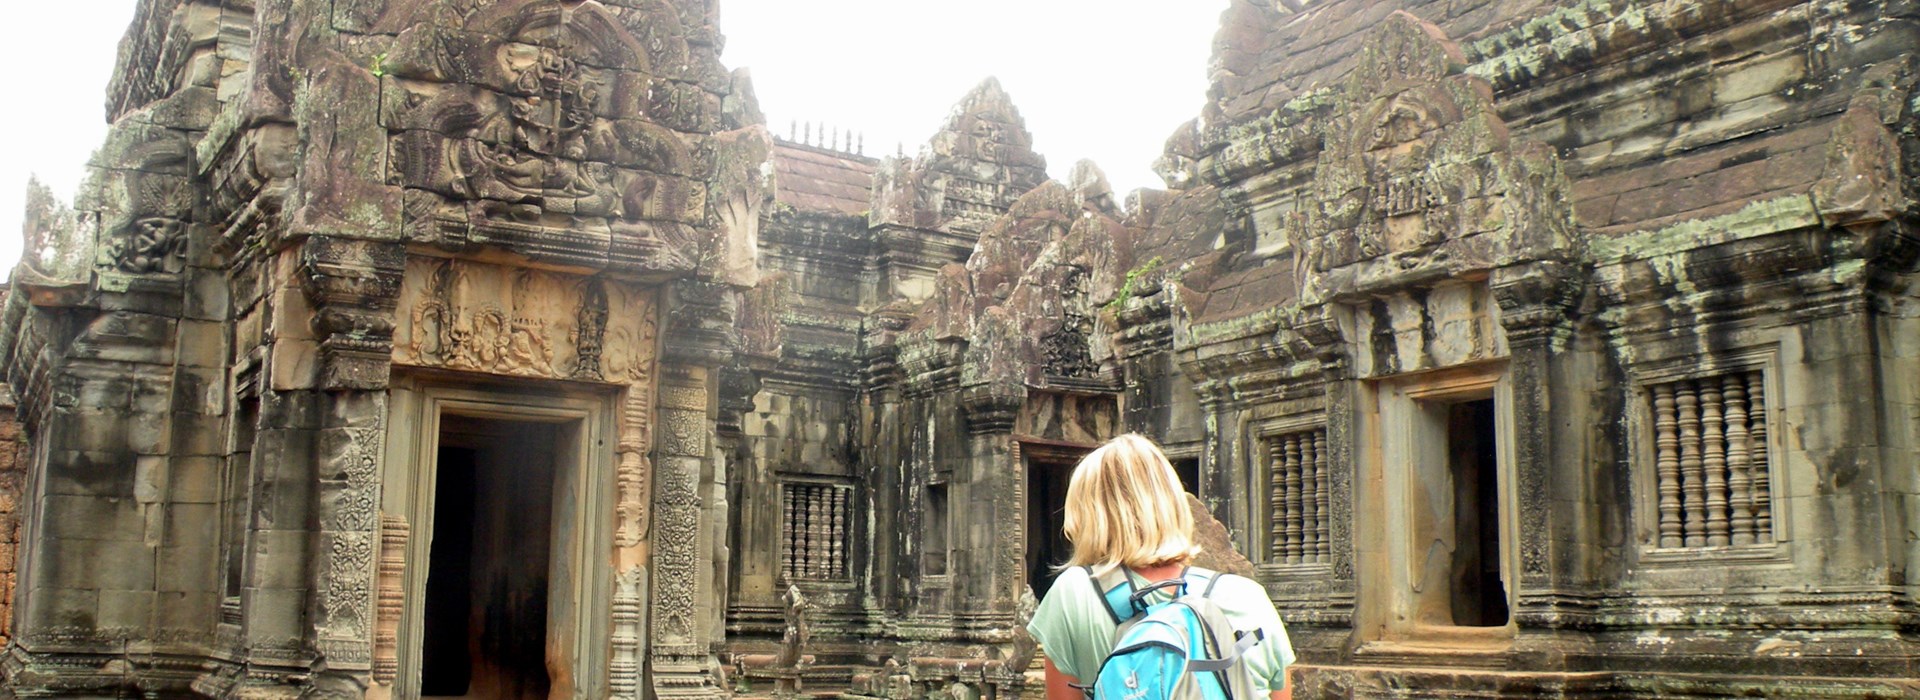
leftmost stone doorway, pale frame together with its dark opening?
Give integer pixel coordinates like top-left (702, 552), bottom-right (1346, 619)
top-left (387, 378), bottom-right (622, 700)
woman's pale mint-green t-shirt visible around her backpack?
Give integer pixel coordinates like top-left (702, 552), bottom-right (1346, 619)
top-left (1027, 568), bottom-right (1294, 690)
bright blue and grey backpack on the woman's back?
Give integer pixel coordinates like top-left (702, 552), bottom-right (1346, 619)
top-left (1083, 566), bottom-right (1265, 700)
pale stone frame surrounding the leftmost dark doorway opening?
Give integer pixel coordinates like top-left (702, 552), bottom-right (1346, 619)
top-left (376, 372), bottom-right (618, 700)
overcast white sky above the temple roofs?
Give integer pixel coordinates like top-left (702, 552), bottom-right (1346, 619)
top-left (0, 0), bottom-right (1227, 274)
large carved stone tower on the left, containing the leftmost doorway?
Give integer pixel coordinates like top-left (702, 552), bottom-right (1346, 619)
top-left (0, 0), bottom-right (772, 698)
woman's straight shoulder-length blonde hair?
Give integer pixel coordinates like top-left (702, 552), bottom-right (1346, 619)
top-left (1064, 433), bottom-right (1200, 573)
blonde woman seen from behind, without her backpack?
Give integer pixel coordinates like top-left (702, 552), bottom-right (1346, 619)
top-left (1027, 435), bottom-right (1294, 700)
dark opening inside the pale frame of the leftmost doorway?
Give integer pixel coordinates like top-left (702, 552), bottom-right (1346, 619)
top-left (420, 416), bottom-right (559, 700)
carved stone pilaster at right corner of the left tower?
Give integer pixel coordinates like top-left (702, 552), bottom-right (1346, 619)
top-left (647, 280), bottom-right (735, 698)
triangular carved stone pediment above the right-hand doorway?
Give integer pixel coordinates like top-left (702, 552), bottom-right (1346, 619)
top-left (1288, 12), bottom-right (1572, 301)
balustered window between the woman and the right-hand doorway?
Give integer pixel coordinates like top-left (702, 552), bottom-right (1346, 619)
top-left (1261, 421), bottom-right (1332, 564)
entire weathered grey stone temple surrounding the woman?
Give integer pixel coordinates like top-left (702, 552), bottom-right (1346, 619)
top-left (0, 0), bottom-right (1920, 700)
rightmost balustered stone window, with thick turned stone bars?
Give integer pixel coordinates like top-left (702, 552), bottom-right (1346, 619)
top-left (1647, 370), bottom-right (1774, 548)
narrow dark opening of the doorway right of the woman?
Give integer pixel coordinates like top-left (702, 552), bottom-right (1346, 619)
top-left (1448, 399), bottom-right (1509, 627)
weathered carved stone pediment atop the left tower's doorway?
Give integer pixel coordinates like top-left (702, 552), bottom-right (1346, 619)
top-left (382, 0), bottom-right (758, 276)
